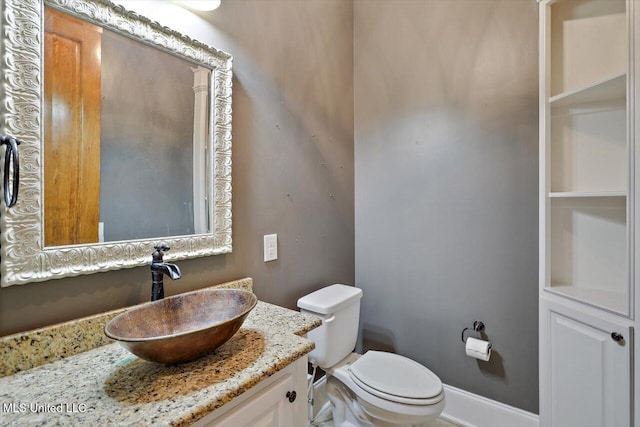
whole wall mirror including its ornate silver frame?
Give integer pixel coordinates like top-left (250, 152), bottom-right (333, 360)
top-left (0, 0), bottom-right (232, 286)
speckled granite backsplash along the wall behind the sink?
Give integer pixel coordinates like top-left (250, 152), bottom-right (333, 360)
top-left (0, 277), bottom-right (253, 377)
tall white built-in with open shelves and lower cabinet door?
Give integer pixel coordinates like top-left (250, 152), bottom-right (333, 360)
top-left (539, 0), bottom-right (640, 427)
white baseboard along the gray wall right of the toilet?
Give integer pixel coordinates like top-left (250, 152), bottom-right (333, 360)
top-left (440, 384), bottom-right (540, 427)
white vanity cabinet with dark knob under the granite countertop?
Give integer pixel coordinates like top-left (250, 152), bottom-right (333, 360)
top-left (194, 356), bottom-right (307, 427)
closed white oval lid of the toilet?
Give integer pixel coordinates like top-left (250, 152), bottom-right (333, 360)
top-left (350, 351), bottom-right (442, 399)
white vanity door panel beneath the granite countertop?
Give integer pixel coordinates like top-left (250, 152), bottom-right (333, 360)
top-left (210, 374), bottom-right (304, 427)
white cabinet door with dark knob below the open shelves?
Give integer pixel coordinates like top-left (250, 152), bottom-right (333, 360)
top-left (540, 307), bottom-right (632, 427)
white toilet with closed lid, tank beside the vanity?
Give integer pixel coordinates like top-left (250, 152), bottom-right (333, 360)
top-left (298, 284), bottom-right (444, 427)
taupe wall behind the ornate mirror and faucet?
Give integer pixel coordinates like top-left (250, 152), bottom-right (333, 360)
top-left (0, 0), bottom-right (354, 335)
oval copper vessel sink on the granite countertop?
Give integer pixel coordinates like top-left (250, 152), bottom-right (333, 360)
top-left (104, 289), bottom-right (258, 363)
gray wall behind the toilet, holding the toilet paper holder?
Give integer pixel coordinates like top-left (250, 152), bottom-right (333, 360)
top-left (354, 0), bottom-right (538, 412)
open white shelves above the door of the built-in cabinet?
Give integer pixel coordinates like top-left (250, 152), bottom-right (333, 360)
top-left (541, 0), bottom-right (629, 314)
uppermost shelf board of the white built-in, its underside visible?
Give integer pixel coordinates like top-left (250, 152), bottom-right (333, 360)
top-left (549, 73), bottom-right (627, 108)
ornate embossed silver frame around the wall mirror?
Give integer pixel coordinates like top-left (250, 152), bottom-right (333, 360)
top-left (0, 0), bottom-right (232, 287)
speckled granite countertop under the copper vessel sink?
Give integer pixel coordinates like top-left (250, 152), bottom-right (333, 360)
top-left (0, 279), bottom-right (321, 426)
